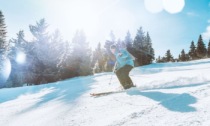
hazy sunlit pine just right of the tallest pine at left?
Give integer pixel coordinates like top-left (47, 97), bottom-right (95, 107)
top-left (47, 30), bottom-right (68, 81)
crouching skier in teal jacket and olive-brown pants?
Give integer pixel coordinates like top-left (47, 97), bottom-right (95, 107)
top-left (110, 45), bottom-right (135, 89)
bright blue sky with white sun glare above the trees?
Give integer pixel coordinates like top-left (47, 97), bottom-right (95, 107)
top-left (0, 0), bottom-right (210, 58)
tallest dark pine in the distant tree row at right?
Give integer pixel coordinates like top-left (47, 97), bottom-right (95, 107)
top-left (196, 35), bottom-right (207, 58)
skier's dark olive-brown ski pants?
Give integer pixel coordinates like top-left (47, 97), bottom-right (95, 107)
top-left (116, 65), bottom-right (134, 89)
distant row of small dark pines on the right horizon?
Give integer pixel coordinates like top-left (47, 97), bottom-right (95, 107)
top-left (156, 35), bottom-right (210, 63)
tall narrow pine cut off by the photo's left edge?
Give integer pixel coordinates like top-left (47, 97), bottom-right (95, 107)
top-left (0, 10), bottom-right (8, 58)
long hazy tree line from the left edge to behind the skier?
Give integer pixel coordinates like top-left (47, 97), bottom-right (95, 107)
top-left (0, 11), bottom-right (154, 87)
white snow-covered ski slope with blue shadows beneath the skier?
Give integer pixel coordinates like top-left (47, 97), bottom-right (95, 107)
top-left (0, 59), bottom-right (210, 126)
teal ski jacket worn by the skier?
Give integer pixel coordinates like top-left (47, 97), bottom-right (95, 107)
top-left (115, 49), bottom-right (134, 70)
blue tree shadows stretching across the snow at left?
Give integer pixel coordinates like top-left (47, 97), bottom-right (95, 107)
top-left (0, 76), bottom-right (95, 113)
